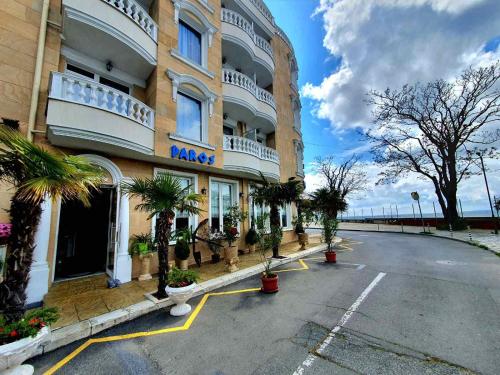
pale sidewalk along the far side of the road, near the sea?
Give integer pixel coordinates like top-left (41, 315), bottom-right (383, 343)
top-left (339, 223), bottom-right (500, 254)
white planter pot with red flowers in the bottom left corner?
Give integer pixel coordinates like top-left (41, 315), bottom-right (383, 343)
top-left (0, 327), bottom-right (50, 375)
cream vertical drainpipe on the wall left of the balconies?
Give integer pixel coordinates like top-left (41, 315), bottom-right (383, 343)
top-left (26, 0), bottom-right (50, 141)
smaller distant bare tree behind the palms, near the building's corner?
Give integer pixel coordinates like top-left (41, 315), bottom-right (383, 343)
top-left (316, 155), bottom-right (368, 217)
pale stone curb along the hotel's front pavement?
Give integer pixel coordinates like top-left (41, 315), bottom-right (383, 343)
top-left (36, 242), bottom-right (336, 357)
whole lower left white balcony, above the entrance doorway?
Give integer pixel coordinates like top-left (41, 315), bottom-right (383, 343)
top-left (47, 72), bottom-right (154, 158)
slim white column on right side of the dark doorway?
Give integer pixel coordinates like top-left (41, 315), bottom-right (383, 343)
top-left (114, 185), bottom-right (132, 283)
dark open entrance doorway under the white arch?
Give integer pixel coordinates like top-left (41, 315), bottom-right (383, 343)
top-left (55, 185), bottom-right (117, 279)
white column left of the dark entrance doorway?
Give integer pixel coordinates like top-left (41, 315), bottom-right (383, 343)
top-left (26, 199), bottom-right (52, 305)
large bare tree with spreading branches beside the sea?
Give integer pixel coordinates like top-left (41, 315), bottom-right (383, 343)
top-left (366, 62), bottom-right (500, 226)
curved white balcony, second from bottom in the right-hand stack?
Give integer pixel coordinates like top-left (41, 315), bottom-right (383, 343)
top-left (222, 69), bottom-right (277, 134)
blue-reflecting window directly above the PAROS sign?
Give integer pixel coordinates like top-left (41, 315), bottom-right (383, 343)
top-left (176, 93), bottom-right (202, 141)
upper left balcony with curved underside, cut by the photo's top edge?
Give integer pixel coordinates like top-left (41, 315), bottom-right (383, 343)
top-left (62, 0), bottom-right (158, 80)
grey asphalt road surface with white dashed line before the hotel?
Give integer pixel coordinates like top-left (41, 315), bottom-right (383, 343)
top-left (29, 232), bottom-right (500, 374)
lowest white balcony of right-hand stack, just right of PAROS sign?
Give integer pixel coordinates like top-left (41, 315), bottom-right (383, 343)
top-left (223, 135), bottom-right (280, 181)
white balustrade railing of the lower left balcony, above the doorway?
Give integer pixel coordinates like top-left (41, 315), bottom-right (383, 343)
top-left (49, 72), bottom-right (155, 129)
